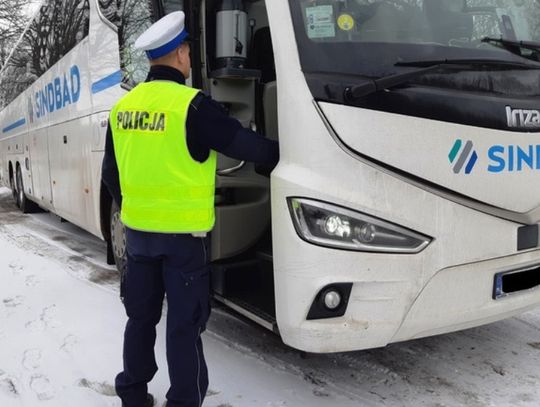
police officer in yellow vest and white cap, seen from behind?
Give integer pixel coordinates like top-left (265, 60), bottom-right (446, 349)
top-left (102, 11), bottom-right (279, 407)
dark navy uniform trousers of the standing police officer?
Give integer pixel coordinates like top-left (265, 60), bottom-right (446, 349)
top-left (115, 229), bottom-right (210, 407)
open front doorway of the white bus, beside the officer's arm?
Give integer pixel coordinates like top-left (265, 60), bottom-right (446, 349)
top-left (199, 1), bottom-right (277, 330)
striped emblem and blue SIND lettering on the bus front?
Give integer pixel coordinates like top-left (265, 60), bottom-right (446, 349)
top-left (448, 139), bottom-right (540, 174)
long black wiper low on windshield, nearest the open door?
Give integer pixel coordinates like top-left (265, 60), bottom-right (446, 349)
top-left (343, 59), bottom-right (540, 102)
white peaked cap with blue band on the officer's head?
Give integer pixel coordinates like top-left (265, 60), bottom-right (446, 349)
top-left (135, 11), bottom-right (188, 59)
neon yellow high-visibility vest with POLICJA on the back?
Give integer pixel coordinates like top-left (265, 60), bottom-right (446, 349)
top-left (110, 81), bottom-right (216, 233)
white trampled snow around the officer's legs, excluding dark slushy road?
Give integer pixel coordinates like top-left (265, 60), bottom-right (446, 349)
top-left (0, 191), bottom-right (360, 407)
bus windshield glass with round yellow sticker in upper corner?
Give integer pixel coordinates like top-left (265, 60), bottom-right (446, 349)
top-left (290, 0), bottom-right (540, 76)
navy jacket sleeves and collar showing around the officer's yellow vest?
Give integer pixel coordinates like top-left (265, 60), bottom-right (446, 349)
top-left (101, 65), bottom-right (279, 204)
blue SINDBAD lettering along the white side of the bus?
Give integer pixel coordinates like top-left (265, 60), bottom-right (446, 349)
top-left (35, 65), bottom-right (81, 119)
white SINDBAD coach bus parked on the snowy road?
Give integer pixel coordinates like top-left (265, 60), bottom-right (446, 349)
top-left (0, 0), bottom-right (540, 352)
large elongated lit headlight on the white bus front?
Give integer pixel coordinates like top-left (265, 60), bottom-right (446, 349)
top-left (288, 198), bottom-right (432, 253)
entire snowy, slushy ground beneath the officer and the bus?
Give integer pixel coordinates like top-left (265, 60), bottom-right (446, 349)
top-left (0, 188), bottom-right (540, 407)
